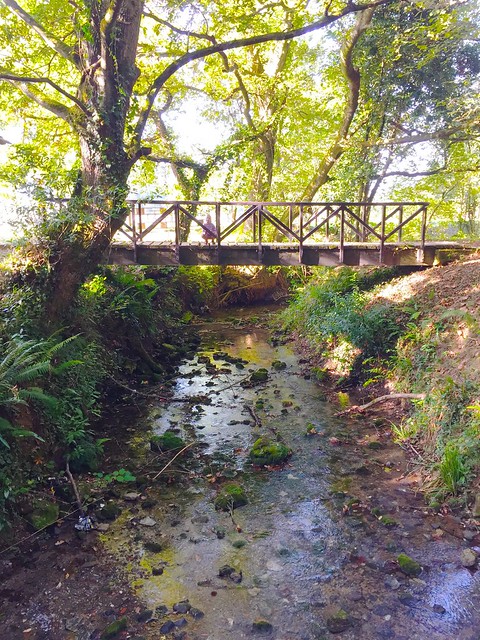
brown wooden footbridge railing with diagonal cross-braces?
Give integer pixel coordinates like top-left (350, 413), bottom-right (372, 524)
top-left (119, 200), bottom-right (428, 261)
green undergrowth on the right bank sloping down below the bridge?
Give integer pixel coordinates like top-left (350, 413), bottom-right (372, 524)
top-left (282, 267), bottom-right (480, 505)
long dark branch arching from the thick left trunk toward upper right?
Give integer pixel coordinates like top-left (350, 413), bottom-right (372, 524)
top-left (130, 0), bottom-right (392, 146)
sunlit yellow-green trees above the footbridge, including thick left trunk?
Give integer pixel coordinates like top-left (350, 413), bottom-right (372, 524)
top-left (0, 0), bottom-right (479, 318)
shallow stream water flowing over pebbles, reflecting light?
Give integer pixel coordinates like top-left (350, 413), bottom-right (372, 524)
top-left (103, 308), bottom-right (480, 640)
